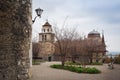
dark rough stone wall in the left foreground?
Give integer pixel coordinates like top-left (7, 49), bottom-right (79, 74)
top-left (0, 0), bottom-right (32, 80)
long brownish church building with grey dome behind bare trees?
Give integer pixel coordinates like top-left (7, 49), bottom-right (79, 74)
top-left (54, 30), bottom-right (106, 63)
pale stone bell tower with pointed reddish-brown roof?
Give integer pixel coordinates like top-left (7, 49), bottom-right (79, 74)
top-left (39, 21), bottom-right (55, 61)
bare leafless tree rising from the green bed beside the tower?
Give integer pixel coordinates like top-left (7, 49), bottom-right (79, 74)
top-left (54, 27), bottom-right (76, 66)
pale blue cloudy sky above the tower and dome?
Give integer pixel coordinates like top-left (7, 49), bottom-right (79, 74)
top-left (32, 0), bottom-right (120, 52)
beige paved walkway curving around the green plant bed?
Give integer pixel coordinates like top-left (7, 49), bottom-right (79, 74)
top-left (31, 62), bottom-right (120, 80)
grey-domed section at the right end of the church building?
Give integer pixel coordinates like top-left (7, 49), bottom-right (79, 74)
top-left (87, 30), bottom-right (107, 62)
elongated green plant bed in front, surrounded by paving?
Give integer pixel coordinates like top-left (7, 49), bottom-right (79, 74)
top-left (50, 64), bottom-right (101, 74)
